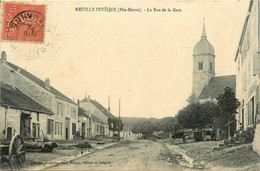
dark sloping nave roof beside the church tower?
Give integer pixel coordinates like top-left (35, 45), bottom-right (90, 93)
top-left (199, 75), bottom-right (236, 99)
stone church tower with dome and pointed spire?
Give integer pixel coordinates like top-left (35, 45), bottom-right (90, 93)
top-left (192, 19), bottom-right (215, 99)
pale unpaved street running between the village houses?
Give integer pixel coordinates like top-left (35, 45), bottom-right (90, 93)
top-left (49, 140), bottom-right (184, 170)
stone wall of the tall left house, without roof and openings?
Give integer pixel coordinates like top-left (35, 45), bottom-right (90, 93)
top-left (0, 61), bottom-right (78, 139)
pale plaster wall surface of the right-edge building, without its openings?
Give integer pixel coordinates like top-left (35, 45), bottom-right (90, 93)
top-left (236, 0), bottom-right (260, 130)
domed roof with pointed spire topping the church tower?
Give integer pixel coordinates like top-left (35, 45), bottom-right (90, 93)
top-left (193, 22), bottom-right (215, 56)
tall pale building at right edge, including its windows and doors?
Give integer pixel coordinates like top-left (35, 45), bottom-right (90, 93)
top-left (235, 0), bottom-right (260, 130)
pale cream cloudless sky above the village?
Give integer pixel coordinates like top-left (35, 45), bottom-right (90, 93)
top-left (0, 1), bottom-right (249, 118)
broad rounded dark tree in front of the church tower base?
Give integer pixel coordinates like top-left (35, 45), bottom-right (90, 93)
top-left (176, 102), bottom-right (219, 129)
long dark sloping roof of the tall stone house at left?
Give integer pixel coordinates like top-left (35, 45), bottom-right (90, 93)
top-left (6, 62), bottom-right (76, 104)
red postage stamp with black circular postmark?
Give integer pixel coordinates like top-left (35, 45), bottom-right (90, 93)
top-left (1, 2), bottom-right (46, 43)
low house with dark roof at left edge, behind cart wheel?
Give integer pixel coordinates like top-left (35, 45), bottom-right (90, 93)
top-left (0, 82), bottom-right (53, 140)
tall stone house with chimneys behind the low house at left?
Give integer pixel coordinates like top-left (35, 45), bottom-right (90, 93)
top-left (0, 52), bottom-right (78, 140)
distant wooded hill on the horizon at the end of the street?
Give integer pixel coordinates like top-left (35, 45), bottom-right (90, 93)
top-left (121, 117), bottom-right (176, 131)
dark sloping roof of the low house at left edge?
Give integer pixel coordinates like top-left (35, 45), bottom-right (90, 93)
top-left (1, 82), bottom-right (53, 114)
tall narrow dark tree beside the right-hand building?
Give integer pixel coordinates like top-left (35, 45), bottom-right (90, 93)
top-left (217, 87), bottom-right (240, 138)
